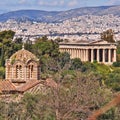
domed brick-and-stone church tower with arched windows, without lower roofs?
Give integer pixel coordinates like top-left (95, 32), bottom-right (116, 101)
top-left (5, 46), bottom-right (40, 86)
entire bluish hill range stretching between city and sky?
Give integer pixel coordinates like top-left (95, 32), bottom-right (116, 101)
top-left (0, 6), bottom-right (120, 22)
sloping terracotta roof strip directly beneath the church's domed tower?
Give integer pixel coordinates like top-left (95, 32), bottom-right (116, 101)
top-left (17, 80), bottom-right (42, 93)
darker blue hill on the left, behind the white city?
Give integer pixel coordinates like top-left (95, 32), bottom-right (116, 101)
top-left (0, 10), bottom-right (59, 22)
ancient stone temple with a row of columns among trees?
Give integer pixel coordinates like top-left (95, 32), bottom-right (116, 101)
top-left (59, 40), bottom-right (116, 64)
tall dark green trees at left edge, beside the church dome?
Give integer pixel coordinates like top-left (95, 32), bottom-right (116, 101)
top-left (0, 30), bottom-right (21, 66)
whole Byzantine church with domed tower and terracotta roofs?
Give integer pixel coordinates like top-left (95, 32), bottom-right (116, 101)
top-left (0, 45), bottom-right (54, 95)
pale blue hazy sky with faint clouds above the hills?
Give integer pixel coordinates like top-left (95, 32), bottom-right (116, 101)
top-left (0, 0), bottom-right (120, 13)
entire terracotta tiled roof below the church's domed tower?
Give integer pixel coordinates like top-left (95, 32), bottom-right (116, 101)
top-left (0, 79), bottom-right (57, 93)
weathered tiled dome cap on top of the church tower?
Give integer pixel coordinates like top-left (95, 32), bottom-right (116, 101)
top-left (10, 47), bottom-right (38, 63)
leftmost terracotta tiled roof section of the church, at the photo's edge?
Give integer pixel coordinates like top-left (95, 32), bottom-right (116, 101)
top-left (0, 80), bottom-right (16, 92)
